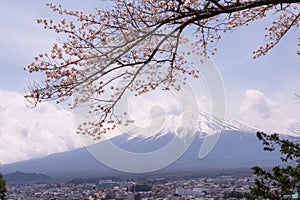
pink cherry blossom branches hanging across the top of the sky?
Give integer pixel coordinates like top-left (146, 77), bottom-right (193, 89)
top-left (24, 0), bottom-right (300, 138)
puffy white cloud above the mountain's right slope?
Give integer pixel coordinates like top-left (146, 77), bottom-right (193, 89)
top-left (239, 89), bottom-right (300, 134)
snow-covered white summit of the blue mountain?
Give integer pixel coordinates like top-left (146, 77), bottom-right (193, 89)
top-left (123, 111), bottom-right (258, 140)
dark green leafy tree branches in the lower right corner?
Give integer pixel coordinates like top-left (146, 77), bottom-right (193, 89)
top-left (246, 132), bottom-right (300, 199)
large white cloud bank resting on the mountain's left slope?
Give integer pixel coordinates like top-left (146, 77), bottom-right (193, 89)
top-left (0, 91), bottom-right (81, 164)
